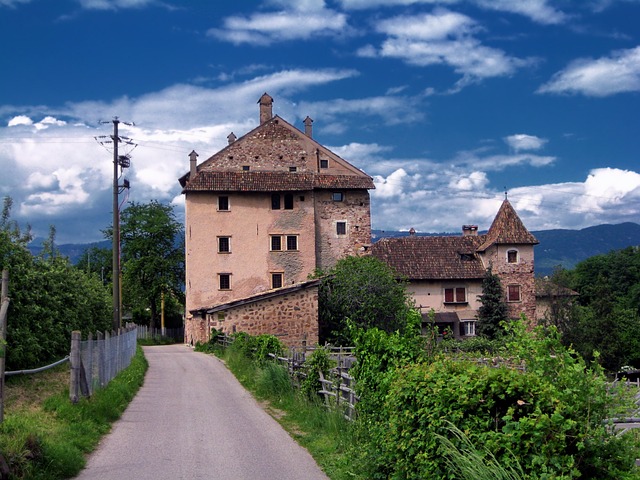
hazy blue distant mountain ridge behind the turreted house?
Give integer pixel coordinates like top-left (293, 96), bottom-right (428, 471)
top-left (371, 222), bottom-right (640, 276)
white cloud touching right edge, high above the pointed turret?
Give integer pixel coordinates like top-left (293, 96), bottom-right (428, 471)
top-left (537, 46), bottom-right (640, 97)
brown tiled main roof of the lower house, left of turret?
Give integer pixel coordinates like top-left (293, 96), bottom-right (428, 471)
top-left (371, 235), bottom-right (485, 280)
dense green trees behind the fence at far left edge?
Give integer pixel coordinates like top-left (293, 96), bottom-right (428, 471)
top-left (0, 199), bottom-right (111, 369)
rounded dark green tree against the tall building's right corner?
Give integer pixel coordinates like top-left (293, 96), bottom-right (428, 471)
top-left (319, 256), bottom-right (410, 344)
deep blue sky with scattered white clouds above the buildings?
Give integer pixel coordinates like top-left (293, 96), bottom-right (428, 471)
top-left (0, 0), bottom-right (640, 243)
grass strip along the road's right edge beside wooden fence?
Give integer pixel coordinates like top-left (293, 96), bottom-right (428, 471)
top-left (210, 349), bottom-right (364, 480)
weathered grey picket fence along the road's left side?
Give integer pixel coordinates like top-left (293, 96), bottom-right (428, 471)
top-left (69, 324), bottom-right (138, 403)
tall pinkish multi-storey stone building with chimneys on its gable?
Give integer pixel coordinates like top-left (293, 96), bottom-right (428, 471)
top-left (180, 93), bottom-right (374, 344)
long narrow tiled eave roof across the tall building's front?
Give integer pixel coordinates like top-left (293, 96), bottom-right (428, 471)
top-left (183, 171), bottom-right (375, 192)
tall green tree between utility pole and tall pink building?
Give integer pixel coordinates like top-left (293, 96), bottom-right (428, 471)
top-left (114, 200), bottom-right (184, 327)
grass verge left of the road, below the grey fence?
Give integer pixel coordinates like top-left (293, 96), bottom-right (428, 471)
top-left (0, 348), bottom-right (148, 480)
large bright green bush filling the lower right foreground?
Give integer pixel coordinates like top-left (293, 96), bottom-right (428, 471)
top-left (366, 324), bottom-right (635, 480)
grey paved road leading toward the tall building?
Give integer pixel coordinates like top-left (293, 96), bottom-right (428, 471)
top-left (77, 345), bottom-right (327, 480)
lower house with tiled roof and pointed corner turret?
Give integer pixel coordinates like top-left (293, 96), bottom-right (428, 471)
top-left (371, 199), bottom-right (538, 338)
